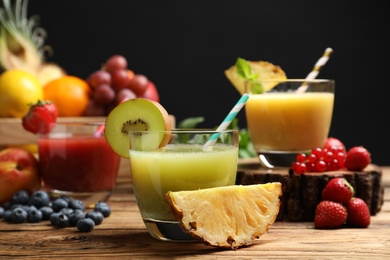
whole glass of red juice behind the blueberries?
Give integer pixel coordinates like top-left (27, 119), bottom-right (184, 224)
top-left (38, 122), bottom-right (120, 207)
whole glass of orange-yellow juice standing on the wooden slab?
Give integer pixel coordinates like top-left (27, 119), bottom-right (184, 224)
top-left (245, 79), bottom-right (335, 168)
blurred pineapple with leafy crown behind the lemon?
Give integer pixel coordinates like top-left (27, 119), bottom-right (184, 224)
top-left (0, 0), bottom-right (65, 85)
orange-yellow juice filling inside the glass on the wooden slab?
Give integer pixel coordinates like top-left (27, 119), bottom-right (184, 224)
top-left (245, 92), bottom-right (334, 153)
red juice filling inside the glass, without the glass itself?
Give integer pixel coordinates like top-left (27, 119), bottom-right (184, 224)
top-left (38, 135), bottom-right (120, 192)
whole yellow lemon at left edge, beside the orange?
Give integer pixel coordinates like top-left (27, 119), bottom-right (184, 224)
top-left (0, 69), bottom-right (43, 118)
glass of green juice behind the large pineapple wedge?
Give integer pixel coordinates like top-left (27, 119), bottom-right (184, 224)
top-left (129, 129), bottom-right (239, 241)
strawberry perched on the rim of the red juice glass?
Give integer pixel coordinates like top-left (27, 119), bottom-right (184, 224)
top-left (22, 100), bottom-right (58, 134)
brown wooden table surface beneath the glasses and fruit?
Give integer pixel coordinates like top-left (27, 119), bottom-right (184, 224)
top-left (0, 159), bottom-right (390, 259)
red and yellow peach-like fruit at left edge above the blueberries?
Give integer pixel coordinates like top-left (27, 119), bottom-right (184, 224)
top-left (0, 148), bottom-right (41, 205)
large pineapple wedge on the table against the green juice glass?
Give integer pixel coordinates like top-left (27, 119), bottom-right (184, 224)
top-left (166, 182), bottom-right (282, 250)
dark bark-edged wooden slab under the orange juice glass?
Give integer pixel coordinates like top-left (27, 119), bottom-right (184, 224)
top-left (236, 160), bottom-right (384, 221)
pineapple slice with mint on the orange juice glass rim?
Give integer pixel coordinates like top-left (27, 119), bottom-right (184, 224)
top-left (225, 61), bottom-right (287, 95)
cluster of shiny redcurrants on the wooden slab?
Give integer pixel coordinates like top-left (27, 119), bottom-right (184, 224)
top-left (292, 146), bottom-right (346, 174)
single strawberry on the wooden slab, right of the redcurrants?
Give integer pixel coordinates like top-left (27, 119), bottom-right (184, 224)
top-left (344, 146), bottom-right (371, 171)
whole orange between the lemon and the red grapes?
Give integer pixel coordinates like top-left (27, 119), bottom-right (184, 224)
top-left (43, 75), bottom-right (91, 117)
